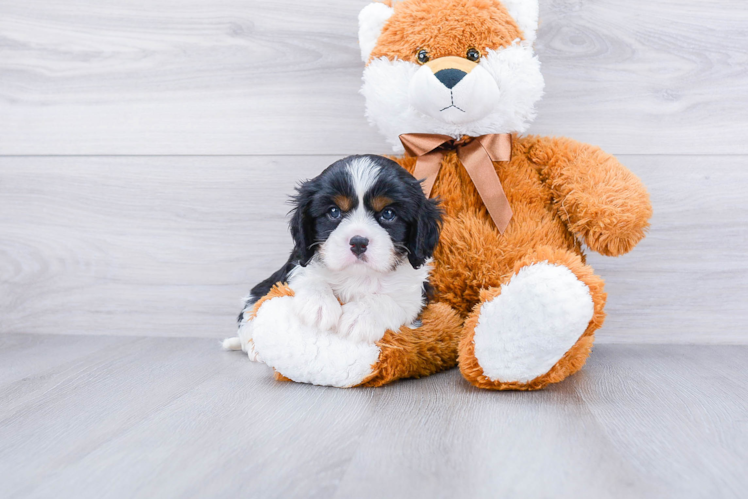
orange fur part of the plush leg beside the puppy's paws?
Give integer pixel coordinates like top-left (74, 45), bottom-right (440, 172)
top-left (361, 304), bottom-right (462, 387)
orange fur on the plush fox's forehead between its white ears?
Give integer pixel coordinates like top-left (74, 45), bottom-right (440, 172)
top-left (369, 0), bottom-right (524, 62)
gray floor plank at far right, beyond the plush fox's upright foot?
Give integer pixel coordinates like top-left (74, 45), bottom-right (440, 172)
top-left (574, 345), bottom-right (748, 498)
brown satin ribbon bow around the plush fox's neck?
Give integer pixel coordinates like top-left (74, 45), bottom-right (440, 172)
top-left (400, 134), bottom-right (512, 233)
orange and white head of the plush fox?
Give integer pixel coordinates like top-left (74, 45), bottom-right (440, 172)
top-left (359, 0), bottom-right (544, 151)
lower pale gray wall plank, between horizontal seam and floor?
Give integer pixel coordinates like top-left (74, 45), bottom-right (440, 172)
top-left (0, 156), bottom-right (748, 343)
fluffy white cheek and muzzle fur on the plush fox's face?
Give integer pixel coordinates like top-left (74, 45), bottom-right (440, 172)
top-left (361, 41), bottom-right (545, 153)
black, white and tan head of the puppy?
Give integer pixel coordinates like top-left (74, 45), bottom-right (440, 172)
top-left (290, 155), bottom-right (441, 272)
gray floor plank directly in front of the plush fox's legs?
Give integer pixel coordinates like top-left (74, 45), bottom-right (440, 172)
top-left (336, 366), bottom-right (660, 498)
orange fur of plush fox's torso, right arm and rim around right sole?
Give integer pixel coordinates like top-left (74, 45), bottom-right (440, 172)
top-left (396, 137), bottom-right (652, 389)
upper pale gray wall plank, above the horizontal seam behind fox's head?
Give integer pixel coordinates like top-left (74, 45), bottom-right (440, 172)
top-left (0, 0), bottom-right (748, 155)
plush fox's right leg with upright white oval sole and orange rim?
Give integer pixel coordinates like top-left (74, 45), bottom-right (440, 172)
top-left (459, 248), bottom-right (606, 390)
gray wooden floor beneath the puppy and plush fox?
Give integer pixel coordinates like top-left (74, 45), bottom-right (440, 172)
top-left (0, 335), bottom-right (748, 498)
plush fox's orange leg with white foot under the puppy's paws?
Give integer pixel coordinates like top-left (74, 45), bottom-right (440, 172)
top-left (247, 284), bottom-right (462, 387)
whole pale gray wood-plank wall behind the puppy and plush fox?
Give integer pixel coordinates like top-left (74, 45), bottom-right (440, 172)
top-left (0, 0), bottom-right (748, 343)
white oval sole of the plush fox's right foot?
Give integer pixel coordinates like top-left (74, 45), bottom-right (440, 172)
top-left (475, 262), bottom-right (594, 383)
